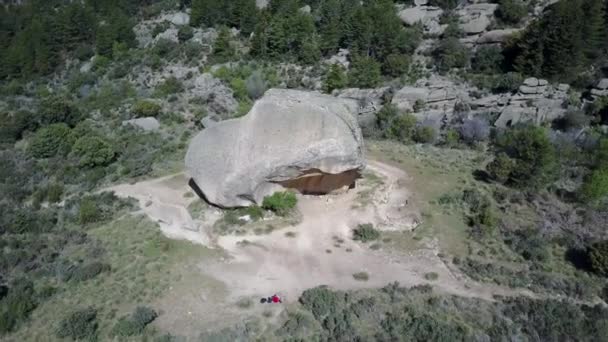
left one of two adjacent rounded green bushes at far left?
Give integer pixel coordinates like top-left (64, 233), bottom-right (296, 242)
top-left (29, 123), bottom-right (73, 158)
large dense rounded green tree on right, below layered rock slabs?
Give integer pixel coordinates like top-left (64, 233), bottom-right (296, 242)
top-left (496, 126), bottom-right (556, 188)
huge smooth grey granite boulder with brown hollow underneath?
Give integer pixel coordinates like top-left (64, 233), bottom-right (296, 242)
top-left (186, 89), bottom-right (365, 207)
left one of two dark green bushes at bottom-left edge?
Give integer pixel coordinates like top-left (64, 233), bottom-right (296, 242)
top-left (55, 308), bottom-right (98, 340)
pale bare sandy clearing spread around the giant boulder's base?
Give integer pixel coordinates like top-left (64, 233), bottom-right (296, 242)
top-left (106, 160), bottom-right (523, 336)
